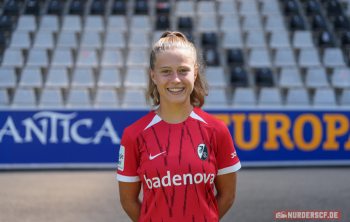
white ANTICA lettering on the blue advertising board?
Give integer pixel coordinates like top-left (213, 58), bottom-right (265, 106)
top-left (0, 111), bottom-right (120, 145)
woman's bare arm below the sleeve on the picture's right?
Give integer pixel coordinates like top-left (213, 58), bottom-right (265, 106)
top-left (215, 172), bottom-right (237, 219)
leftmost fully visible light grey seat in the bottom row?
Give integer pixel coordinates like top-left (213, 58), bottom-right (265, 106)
top-left (12, 88), bottom-right (36, 108)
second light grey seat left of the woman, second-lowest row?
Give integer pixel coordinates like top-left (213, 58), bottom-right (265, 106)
top-left (97, 68), bottom-right (122, 88)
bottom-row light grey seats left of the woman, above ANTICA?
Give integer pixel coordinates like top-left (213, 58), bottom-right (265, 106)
top-left (0, 88), bottom-right (147, 109)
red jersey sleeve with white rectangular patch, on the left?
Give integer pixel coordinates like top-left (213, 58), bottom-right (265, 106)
top-left (117, 130), bottom-right (140, 182)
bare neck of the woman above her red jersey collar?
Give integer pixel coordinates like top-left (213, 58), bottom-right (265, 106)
top-left (155, 101), bottom-right (193, 124)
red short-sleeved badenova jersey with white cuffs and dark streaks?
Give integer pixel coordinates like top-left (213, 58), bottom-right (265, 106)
top-left (117, 107), bottom-right (241, 222)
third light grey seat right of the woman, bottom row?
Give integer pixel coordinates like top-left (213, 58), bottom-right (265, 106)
top-left (258, 88), bottom-right (282, 106)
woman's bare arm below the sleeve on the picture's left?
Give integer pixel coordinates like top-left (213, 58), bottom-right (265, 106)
top-left (119, 181), bottom-right (141, 222)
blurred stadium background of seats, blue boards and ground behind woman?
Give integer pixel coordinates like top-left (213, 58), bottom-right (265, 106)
top-left (0, 0), bottom-right (350, 222)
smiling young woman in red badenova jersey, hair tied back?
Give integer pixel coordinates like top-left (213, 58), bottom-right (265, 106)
top-left (117, 31), bottom-right (241, 222)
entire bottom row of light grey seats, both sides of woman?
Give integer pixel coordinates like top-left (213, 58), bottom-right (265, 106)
top-left (0, 88), bottom-right (350, 108)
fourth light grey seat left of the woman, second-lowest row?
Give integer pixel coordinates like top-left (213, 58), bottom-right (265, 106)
top-left (45, 68), bottom-right (69, 88)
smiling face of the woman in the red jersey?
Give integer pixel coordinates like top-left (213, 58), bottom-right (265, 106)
top-left (150, 49), bottom-right (197, 107)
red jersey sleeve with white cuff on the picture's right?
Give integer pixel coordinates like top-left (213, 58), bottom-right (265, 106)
top-left (216, 122), bottom-right (241, 176)
